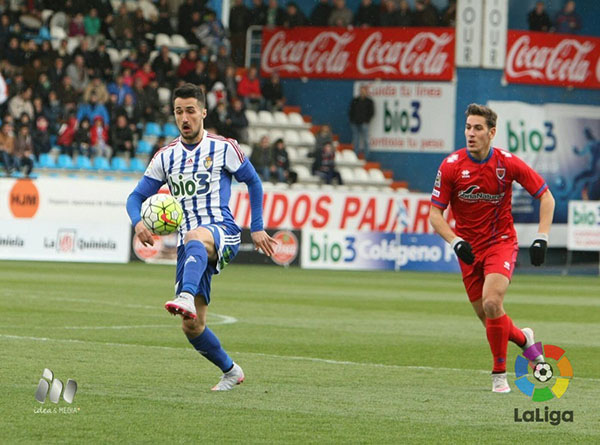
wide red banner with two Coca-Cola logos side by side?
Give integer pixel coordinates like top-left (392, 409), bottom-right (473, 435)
top-left (261, 27), bottom-right (454, 80)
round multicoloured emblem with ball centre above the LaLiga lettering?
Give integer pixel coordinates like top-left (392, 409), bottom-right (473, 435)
top-left (515, 342), bottom-right (573, 402)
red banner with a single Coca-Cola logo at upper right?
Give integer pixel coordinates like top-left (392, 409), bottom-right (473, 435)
top-left (504, 31), bottom-right (600, 88)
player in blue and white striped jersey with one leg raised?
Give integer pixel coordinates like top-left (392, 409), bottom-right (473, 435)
top-left (127, 83), bottom-right (277, 391)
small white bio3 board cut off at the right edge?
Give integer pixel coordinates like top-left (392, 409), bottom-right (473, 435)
top-left (567, 201), bottom-right (600, 251)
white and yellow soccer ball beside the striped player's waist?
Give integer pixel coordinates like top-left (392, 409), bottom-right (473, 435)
top-left (142, 193), bottom-right (183, 235)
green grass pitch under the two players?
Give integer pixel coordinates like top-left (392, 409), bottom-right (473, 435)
top-left (0, 262), bottom-right (600, 444)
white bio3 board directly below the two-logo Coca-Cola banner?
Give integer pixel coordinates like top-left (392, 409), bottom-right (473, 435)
top-left (354, 82), bottom-right (456, 153)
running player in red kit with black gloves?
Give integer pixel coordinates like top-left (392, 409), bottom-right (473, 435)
top-left (429, 104), bottom-right (554, 393)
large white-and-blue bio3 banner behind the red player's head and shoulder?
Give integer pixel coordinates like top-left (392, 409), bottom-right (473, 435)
top-left (488, 101), bottom-right (600, 224)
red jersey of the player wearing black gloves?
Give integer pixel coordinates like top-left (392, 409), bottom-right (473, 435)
top-left (431, 147), bottom-right (548, 251)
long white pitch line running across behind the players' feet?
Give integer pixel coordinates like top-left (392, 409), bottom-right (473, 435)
top-left (0, 334), bottom-right (600, 382)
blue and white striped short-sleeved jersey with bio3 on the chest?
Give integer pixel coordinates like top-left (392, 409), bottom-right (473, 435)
top-left (144, 130), bottom-right (248, 244)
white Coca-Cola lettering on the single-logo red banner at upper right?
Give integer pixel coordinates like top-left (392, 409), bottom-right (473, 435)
top-left (506, 35), bottom-right (600, 83)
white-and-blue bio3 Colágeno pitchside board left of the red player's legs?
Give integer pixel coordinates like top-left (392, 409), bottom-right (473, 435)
top-left (302, 230), bottom-right (460, 272)
